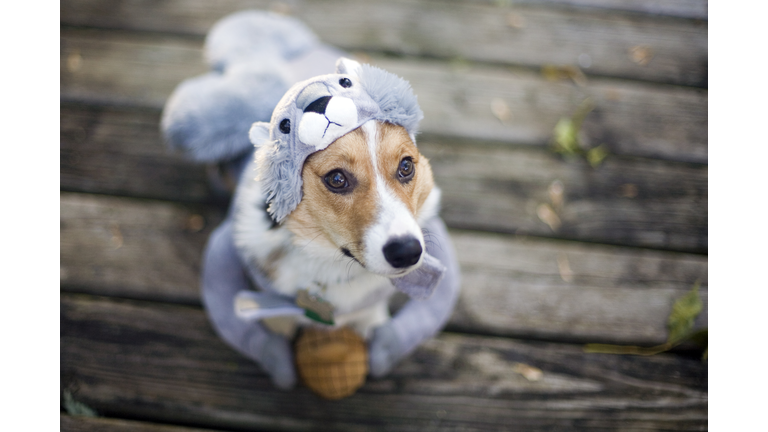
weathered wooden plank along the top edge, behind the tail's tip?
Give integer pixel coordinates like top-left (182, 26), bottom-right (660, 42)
top-left (61, 0), bottom-right (708, 87)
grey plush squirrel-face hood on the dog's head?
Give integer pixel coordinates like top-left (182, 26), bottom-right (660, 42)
top-left (249, 58), bottom-right (424, 223)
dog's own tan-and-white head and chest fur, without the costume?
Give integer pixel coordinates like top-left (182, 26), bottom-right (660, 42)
top-left (232, 120), bottom-right (440, 339)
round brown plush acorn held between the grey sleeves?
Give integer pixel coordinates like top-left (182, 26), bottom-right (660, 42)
top-left (294, 327), bottom-right (368, 399)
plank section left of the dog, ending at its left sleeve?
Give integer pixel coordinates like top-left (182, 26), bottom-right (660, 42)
top-left (59, 194), bottom-right (222, 303)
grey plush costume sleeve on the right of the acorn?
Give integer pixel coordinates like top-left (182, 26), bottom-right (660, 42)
top-left (369, 217), bottom-right (461, 377)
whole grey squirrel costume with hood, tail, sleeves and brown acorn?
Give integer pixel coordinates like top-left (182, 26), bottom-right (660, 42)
top-left (161, 11), bottom-right (459, 398)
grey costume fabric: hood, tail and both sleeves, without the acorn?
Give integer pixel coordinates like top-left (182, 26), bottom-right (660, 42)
top-left (161, 11), bottom-right (459, 388)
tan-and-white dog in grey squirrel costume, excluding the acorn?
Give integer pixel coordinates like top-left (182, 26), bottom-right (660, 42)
top-left (161, 11), bottom-right (459, 389)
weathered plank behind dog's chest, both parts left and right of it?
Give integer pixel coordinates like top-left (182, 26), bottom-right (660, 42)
top-left (60, 193), bottom-right (708, 344)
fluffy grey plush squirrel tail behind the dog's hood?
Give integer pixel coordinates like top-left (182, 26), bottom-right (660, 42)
top-left (161, 11), bottom-right (330, 163)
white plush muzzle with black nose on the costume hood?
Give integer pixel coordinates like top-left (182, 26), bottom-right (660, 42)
top-left (298, 96), bottom-right (357, 150)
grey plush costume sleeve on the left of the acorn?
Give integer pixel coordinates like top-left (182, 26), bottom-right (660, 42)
top-left (202, 219), bottom-right (296, 389)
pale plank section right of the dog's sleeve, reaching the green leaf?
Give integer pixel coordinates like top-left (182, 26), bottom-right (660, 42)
top-left (450, 231), bottom-right (708, 344)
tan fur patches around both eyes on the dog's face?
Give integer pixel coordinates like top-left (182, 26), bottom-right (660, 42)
top-left (286, 123), bottom-right (434, 266)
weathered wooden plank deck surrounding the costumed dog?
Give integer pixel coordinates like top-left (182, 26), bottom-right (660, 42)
top-left (60, 0), bottom-right (708, 432)
